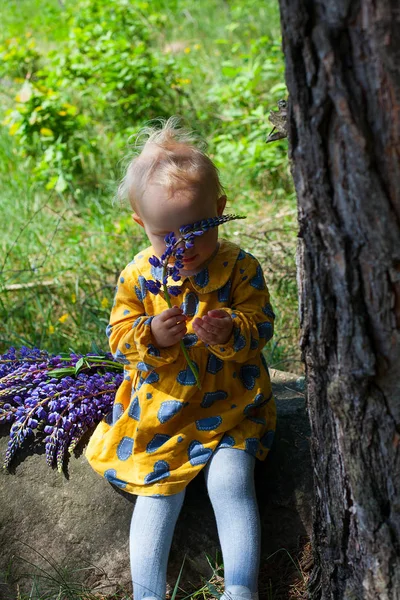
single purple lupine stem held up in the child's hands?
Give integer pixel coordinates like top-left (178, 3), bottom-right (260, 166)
top-left (146, 215), bottom-right (246, 388)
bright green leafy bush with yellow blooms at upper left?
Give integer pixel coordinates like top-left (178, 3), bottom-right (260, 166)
top-left (2, 0), bottom-right (174, 193)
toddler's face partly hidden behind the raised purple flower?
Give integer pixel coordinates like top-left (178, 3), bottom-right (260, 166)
top-left (133, 184), bottom-right (226, 271)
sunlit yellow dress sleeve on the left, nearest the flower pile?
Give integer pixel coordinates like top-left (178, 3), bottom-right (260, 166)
top-left (106, 265), bottom-right (179, 372)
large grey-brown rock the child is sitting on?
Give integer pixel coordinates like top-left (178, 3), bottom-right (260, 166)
top-left (0, 370), bottom-right (313, 598)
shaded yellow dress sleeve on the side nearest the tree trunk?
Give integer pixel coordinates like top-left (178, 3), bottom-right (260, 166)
top-left (208, 255), bottom-right (275, 363)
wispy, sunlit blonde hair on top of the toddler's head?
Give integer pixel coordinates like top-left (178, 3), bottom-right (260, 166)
top-left (117, 117), bottom-right (224, 210)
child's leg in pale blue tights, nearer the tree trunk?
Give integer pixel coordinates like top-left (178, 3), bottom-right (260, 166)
top-left (205, 448), bottom-right (261, 600)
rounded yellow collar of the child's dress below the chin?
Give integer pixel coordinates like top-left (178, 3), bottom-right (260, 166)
top-left (134, 239), bottom-right (240, 294)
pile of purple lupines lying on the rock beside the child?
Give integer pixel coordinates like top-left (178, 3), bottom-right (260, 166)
top-left (0, 347), bottom-right (123, 472)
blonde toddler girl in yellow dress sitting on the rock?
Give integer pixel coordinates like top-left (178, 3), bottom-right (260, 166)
top-left (86, 119), bottom-right (276, 600)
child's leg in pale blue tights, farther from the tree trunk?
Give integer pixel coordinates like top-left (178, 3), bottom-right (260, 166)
top-left (129, 490), bottom-right (185, 600)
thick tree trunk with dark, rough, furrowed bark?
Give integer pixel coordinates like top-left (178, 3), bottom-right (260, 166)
top-left (280, 0), bottom-right (400, 600)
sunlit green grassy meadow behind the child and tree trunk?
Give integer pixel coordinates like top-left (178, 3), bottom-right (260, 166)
top-left (0, 0), bottom-right (302, 373)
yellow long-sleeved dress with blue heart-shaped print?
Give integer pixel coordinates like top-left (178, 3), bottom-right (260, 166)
top-left (86, 240), bottom-right (276, 496)
